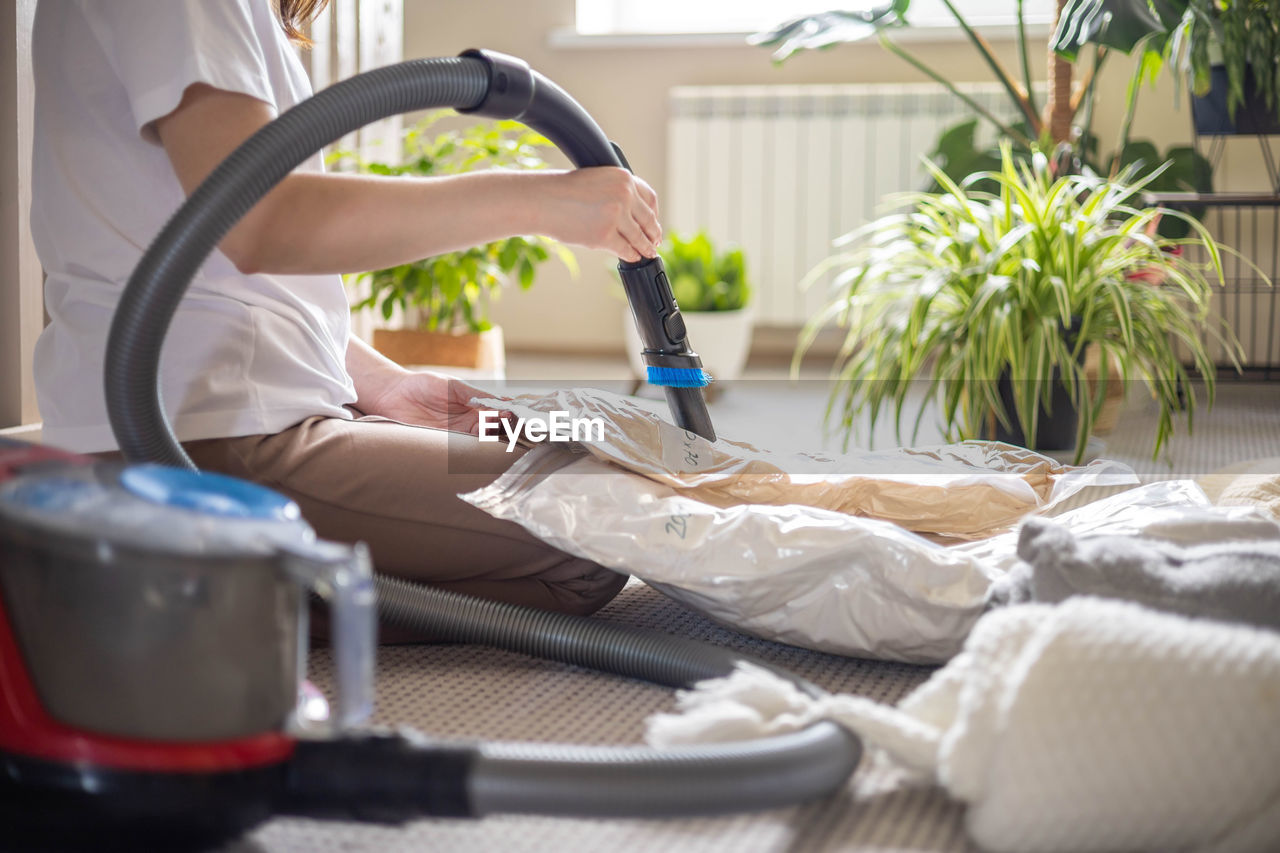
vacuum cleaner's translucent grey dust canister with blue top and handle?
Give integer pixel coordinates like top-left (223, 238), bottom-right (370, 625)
top-left (0, 455), bottom-right (374, 743)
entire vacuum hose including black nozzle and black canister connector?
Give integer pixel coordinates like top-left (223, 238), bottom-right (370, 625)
top-left (106, 51), bottom-right (861, 816)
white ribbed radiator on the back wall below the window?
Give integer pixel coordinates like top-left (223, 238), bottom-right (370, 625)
top-left (663, 83), bottom-right (1010, 327)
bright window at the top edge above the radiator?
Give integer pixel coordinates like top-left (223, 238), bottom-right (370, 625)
top-left (577, 0), bottom-right (1053, 36)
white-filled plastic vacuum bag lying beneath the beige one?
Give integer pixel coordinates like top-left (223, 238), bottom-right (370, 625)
top-left (462, 427), bottom-right (1162, 663)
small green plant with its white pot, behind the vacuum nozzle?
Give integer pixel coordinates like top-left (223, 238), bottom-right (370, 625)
top-left (623, 232), bottom-right (753, 382)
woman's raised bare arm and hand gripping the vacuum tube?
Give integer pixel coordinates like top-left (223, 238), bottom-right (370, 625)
top-left (155, 85), bottom-right (662, 274)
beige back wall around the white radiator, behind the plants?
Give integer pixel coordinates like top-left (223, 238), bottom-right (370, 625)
top-left (404, 0), bottom-right (1223, 351)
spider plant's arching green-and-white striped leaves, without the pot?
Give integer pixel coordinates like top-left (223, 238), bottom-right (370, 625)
top-left (796, 143), bottom-right (1240, 462)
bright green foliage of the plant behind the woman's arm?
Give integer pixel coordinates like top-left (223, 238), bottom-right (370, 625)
top-left (332, 110), bottom-right (577, 332)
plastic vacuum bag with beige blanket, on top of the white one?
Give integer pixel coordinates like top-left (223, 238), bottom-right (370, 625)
top-left (471, 389), bottom-right (1137, 539)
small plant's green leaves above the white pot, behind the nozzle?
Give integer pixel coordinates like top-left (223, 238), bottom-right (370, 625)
top-left (659, 232), bottom-right (751, 311)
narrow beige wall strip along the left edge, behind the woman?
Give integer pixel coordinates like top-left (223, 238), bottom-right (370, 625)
top-left (0, 0), bottom-right (45, 429)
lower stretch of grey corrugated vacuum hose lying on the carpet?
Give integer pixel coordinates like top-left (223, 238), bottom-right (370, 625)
top-left (375, 576), bottom-right (861, 817)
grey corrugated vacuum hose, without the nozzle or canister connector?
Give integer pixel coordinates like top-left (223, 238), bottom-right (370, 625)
top-left (106, 49), bottom-right (860, 816)
